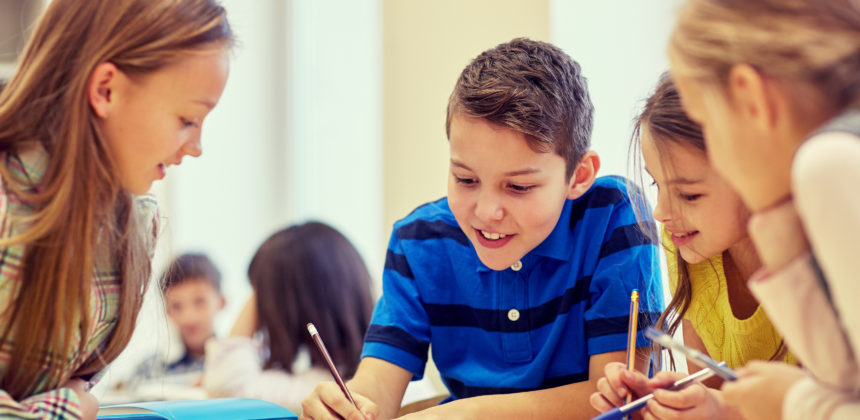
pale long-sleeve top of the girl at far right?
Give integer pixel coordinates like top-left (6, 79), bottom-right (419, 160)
top-left (750, 127), bottom-right (860, 420)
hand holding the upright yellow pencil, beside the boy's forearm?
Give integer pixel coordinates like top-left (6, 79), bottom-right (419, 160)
top-left (590, 362), bottom-right (652, 413)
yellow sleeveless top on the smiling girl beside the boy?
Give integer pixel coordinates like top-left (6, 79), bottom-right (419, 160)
top-left (663, 231), bottom-right (797, 369)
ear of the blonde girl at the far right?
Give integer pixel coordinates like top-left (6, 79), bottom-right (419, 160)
top-left (728, 64), bottom-right (776, 131)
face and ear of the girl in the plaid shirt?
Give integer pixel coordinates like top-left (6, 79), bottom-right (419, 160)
top-left (90, 48), bottom-right (229, 194)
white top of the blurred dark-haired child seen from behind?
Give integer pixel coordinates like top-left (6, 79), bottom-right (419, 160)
top-left (203, 337), bottom-right (331, 414)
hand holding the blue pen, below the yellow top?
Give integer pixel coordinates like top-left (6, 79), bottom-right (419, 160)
top-left (642, 372), bottom-right (726, 420)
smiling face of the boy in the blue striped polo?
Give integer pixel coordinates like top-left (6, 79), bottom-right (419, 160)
top-left (448, 113), bottom-right (579, 270)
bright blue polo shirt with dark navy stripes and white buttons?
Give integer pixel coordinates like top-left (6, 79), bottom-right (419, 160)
top-left (362, 177), bottom-right (663, 399)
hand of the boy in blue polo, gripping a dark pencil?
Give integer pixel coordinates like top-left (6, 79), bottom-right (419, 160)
top-left (299, 381), bottom-right (379, 420)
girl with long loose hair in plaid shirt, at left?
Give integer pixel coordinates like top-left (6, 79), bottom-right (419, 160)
top-left (0, 0), bottom-right (232, 418)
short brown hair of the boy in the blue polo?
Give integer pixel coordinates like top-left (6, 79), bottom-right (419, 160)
top-left (445, 38), bottom-right (594, 179)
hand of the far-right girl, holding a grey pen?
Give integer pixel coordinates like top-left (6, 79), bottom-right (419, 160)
top-left (723, 361), bottom-right (806, 420)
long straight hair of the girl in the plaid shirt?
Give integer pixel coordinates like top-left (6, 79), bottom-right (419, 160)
top-left (0, 0), bottom-right (233, 398)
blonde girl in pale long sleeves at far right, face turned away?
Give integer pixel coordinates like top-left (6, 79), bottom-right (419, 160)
top-left (669, 0), bottom-right (860, 419)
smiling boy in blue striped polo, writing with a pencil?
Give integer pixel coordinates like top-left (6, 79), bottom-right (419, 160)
top-left (303, 39), bottom-right (662, 419)
